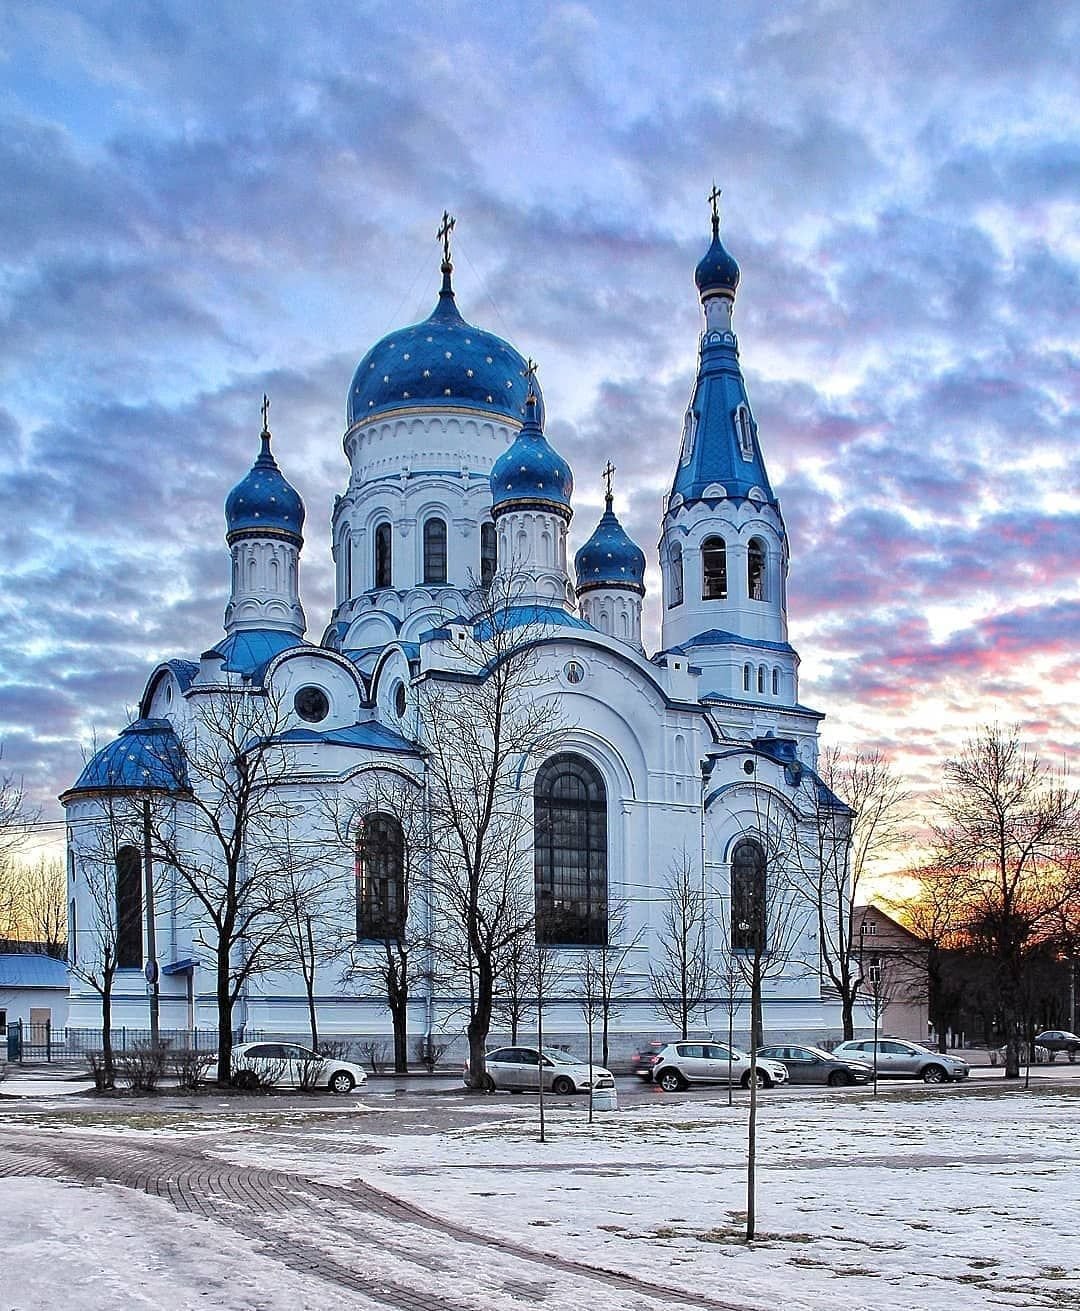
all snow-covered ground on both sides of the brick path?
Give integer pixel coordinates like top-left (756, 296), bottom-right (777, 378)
top-left (0, 1087), bottom-right (1080, 1311)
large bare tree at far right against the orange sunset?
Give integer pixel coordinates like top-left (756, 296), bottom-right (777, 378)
top-left (925, 725), bottom-right (1080, 1079)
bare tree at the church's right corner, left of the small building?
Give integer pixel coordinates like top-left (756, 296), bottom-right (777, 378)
top-left (792, 747), bottom-right (910, 1038)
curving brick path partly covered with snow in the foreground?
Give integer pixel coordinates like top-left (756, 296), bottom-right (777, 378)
top-left (0, 1126), bottom-right (746, 1311)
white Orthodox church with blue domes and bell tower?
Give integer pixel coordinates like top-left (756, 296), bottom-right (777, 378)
top-left (62, 199), bottom-right (847, 1051)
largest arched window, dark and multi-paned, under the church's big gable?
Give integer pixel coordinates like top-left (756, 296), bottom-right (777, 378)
top-left (533, 755), bottom-right (607, 947)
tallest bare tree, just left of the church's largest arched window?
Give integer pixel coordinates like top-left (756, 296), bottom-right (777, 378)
top-left (417, 578), bottom-right (566, 1086)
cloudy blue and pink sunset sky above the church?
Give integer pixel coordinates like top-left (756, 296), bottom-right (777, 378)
top-left (0, 0), bottom-right (1080, 839)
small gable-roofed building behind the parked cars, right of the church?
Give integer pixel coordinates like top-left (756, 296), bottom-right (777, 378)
top-left (852, 906), bottom-right (929, 1042)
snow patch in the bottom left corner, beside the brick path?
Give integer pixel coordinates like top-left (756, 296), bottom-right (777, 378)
top-left (0, 1179), bottom-right (376, 1311)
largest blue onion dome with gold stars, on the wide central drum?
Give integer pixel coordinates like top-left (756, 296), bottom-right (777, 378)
top-left (347, 265), bottom-right (543, 427)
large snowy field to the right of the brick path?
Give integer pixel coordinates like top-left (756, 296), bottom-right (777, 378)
top-left (208, 1089), bottom-right (1080, 1311)
